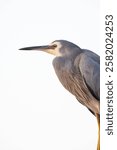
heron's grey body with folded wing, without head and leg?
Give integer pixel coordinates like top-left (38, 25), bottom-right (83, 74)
top-left (53, 41), bottom-right (100, 114)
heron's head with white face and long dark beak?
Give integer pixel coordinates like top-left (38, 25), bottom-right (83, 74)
top-left (19, 40), bottom-right (81, 56)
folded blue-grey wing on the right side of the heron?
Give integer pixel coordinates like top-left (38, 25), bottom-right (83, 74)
top-left (74, 50), bottom-right (100, 100)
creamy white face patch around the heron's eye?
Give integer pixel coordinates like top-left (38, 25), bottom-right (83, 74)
top-left (46, 42), bottom-right (62, 56)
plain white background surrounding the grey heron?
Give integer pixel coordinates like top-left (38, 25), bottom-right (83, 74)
top-left (0, 0), bottom-right (99, 150)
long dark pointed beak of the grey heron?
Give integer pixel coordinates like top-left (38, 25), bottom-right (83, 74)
top-left (19, 45), bottom-right (49, 51)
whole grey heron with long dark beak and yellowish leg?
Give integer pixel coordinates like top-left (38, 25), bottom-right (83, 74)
top-left (19, 40), bottom-right (100, 150)
